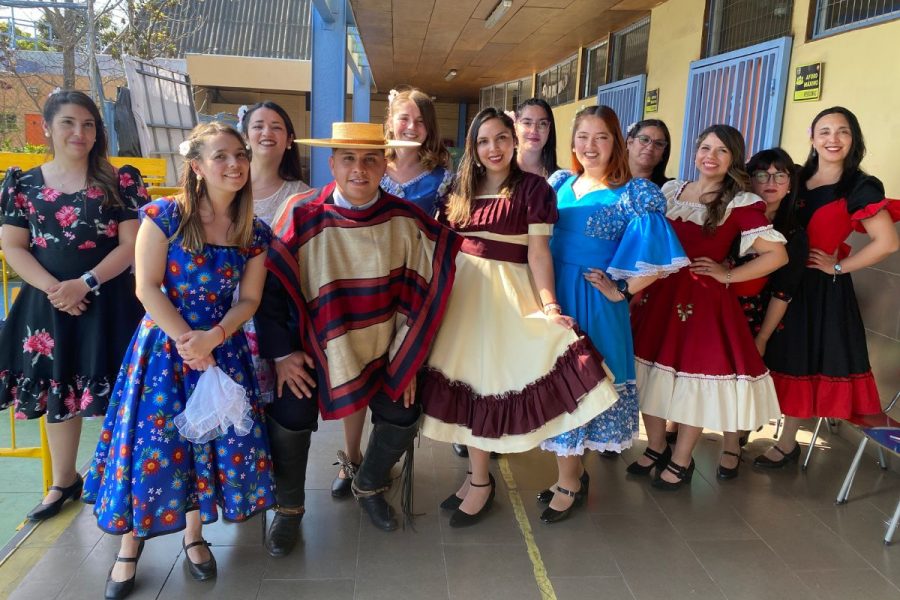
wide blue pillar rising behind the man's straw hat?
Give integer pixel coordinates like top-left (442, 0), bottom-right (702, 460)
top-left (309, 0), bottom-right (347, 187)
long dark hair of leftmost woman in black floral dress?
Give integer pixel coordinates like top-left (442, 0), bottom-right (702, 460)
top-left (41, 90), bottom-right (125, 208)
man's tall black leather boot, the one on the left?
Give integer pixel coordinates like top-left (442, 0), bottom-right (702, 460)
top-left (266, 417), bottom-right (312, 558)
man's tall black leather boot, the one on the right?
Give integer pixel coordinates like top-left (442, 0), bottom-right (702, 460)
top-left (353, 421), bottom-right (419, 531)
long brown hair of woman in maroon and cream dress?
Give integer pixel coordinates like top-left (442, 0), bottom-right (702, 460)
top-left (447, 106), bottom-right (525, 226)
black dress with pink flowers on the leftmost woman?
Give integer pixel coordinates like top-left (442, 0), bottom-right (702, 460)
top-left (0, 166), bottom-right (149, 423)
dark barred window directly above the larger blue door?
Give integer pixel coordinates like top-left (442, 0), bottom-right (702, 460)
top-left (706, 0), bottom-right (794, 56)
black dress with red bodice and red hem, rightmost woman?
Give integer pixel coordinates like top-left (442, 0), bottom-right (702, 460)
top-left (766, 173), bottom-right (900, 418)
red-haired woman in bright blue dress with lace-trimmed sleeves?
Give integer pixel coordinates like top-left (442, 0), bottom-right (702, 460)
top-left (538, 106), bottom-right (690, 523)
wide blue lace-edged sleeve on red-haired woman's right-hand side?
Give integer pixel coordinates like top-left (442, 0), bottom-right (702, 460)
top-left (606, 178), bottom-right (690, 279)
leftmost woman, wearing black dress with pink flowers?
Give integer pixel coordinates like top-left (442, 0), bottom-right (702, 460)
top-left (0, 91), bottom-right (149, 520)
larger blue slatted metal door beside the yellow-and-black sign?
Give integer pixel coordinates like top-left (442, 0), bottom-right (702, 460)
top-left (679, 37), bottom-right (791, 179)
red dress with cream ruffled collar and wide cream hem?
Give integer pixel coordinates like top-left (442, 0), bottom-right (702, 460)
top-left (632, 181), bottom-right (785, 431)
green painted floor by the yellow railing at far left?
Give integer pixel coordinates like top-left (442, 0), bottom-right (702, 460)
top-left (0, 418), bottom-right (103, 547)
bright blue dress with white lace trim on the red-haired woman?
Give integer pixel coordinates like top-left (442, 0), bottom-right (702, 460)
top-left (541, 175), bottom-right (690, 456)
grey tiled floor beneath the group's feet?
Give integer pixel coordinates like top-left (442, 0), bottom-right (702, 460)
top-left (1, 423), bottom-right (900, 600)
